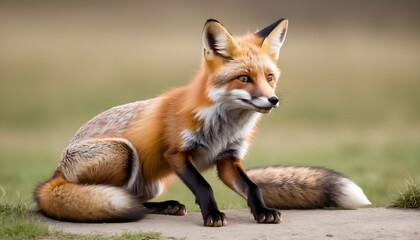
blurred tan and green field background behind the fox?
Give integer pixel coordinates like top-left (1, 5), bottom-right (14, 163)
top-left (0, 0), bottom-right (420, 210)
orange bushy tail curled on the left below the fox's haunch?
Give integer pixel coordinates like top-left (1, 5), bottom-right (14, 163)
top-left (35, 177), bottom-right (146, 222)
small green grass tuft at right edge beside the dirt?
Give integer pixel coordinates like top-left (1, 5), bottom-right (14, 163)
top-left (391, 179), bottom-right (420, 208)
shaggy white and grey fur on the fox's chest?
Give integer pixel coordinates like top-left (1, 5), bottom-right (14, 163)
top-left (181, 104), bottom-right (260, 170)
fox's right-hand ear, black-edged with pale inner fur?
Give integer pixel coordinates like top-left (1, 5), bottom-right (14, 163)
top-left (255, 18), bottom-right (289, 60)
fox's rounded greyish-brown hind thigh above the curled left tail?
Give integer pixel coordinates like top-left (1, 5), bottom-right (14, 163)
top-left (57, 138), bottom-right (146, 198)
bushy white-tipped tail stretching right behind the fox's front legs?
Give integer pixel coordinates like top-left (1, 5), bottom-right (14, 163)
top-left (247, 167), bottom-right (371, 209)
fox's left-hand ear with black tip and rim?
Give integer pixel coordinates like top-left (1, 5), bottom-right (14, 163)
top-left (203, 19), bottom-right (238, 60)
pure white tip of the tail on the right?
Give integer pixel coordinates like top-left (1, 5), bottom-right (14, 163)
top-left (337, 179), bottom-right (372, 209)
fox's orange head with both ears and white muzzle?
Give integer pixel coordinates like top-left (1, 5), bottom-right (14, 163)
top-left (203, 18), bottom-right (288, 113)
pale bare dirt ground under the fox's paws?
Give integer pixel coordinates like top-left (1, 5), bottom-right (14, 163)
top-left (40, 208), bottom-right (420, 240)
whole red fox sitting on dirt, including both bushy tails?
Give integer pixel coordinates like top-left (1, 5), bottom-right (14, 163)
top-left (35, 18), bottom-right (370, 227)
